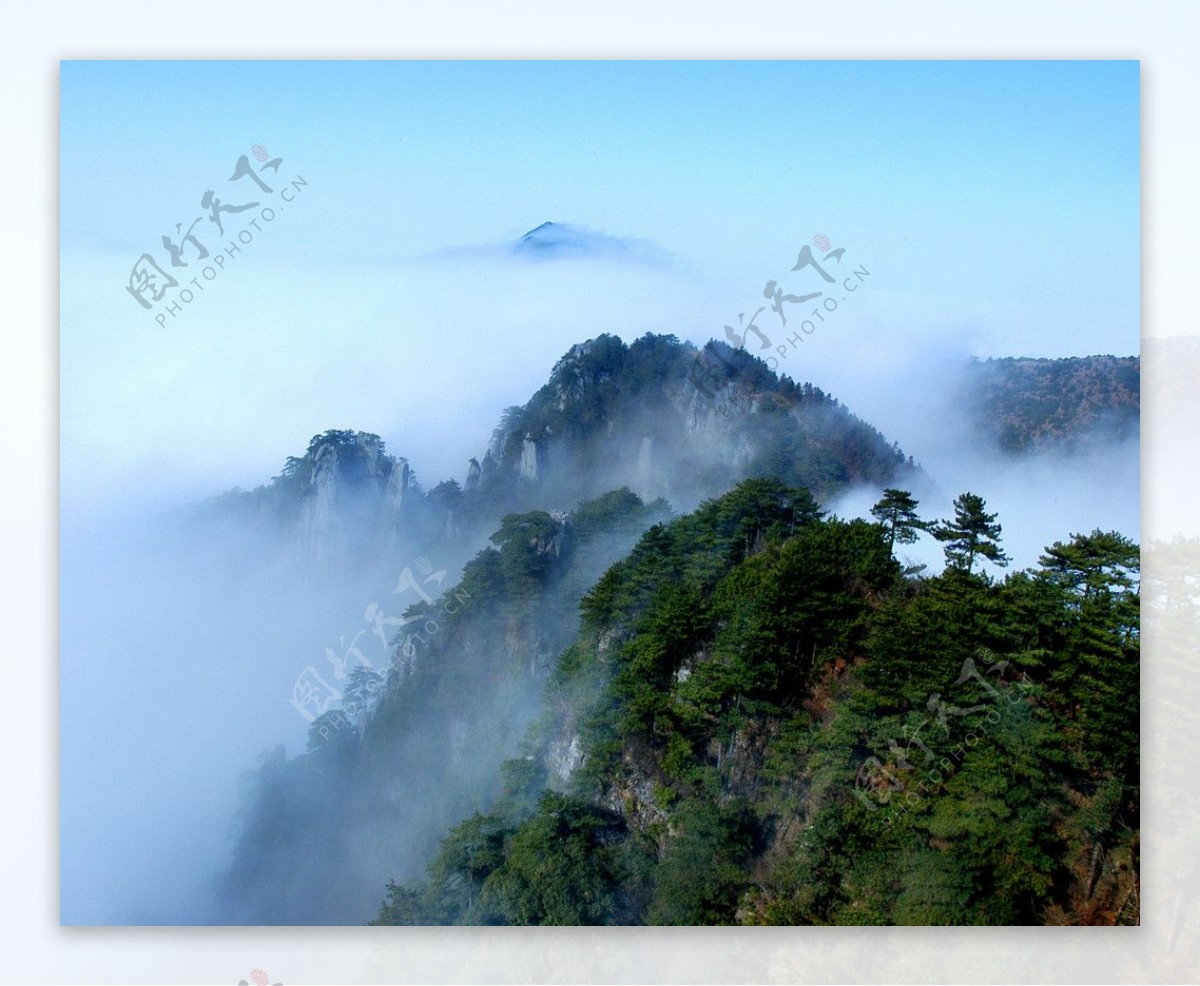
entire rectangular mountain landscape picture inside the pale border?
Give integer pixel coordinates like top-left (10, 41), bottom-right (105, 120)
top-left (60, 60), bottom-right (1137, 940)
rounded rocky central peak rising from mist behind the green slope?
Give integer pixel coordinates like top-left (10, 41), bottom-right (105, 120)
top-left (463, 336), bottom-right (908, 518)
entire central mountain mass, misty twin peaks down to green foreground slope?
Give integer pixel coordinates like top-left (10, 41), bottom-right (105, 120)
top-left (206, 336), bottom-right (1138, 924)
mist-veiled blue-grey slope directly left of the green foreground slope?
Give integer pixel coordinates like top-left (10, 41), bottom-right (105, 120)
top-left (222, 489), bottom-right (667, 924)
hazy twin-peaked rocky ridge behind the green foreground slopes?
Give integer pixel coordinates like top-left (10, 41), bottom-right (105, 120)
top-left (205, 335), bottom-right (914, 564)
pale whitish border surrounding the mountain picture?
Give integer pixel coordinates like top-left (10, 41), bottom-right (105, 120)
top-left (0, 2), bottom-right (1200, 982)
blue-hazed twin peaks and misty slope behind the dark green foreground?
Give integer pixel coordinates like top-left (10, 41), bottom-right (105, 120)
top-left (211, 336), bottom-right (914, 924)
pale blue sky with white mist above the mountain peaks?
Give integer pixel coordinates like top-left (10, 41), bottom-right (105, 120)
top-left (61, 61), bottom-right (1140, 507)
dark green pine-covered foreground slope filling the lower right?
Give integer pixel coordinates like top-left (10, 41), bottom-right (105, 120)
top-left (378, 480), bottom-right (1139, 925)
